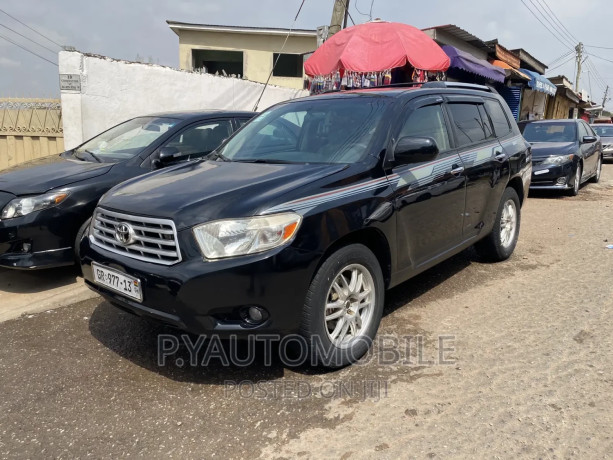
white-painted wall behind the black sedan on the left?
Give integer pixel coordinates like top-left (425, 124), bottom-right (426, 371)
top-left (59, 51), bottom-right (308, 149)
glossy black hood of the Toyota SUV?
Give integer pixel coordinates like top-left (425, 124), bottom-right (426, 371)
top-left (99, 161), bottom-right (346, 229)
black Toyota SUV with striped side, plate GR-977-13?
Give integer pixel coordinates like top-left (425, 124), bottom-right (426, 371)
top-left (81, 82), bottom-right (532, 367)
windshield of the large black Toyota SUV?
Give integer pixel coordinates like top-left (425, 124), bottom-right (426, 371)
top-left (219, 96), bottom-right (388, 163)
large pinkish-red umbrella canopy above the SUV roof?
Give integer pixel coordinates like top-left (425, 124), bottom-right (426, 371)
top-left (304, 21), bottom-right (449, 76)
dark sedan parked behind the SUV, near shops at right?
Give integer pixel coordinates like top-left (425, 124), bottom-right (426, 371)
top-left (522, 120), bottom-right (602, 196)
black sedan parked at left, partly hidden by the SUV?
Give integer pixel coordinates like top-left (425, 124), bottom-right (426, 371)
top-left (0, 111), bottom-right (254, 269)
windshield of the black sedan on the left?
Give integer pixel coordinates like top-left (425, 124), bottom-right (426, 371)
top-left (74, 117), bottom-right (179, 162)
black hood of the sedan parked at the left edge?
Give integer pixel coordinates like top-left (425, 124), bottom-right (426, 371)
top-left (0, 155), bottom-right (113, 195)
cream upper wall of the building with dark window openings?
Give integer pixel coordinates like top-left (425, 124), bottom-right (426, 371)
top-left (178, 30), bottom-right (317, 89)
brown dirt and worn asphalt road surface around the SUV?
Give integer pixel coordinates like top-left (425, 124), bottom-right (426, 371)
top-left (0, 164), bottom-right (613, 459)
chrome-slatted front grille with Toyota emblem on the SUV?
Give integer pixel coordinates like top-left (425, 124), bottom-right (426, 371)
top-left (90, 208), bottom-right (181, 265)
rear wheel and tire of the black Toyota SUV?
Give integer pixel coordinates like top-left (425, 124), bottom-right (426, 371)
top-left (475, 187), bottom-right (521, 262)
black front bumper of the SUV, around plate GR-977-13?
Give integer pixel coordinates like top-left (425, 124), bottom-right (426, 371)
top-left (80, 238), bottom-right (320, 337)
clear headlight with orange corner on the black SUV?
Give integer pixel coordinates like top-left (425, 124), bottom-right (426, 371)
top-left (193, 213), bottom-right (302, 259)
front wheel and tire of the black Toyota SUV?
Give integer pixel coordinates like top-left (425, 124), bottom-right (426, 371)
top-left (300, 244), bottom-right (385, 369)
